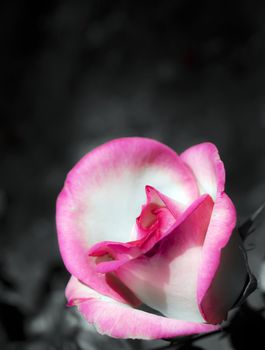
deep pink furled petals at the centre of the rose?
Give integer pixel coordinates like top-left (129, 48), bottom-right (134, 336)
top-left (88, 186), bottom-right (180, 273)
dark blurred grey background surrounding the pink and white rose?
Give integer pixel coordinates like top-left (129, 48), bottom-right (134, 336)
top-left (0, 0), bottom-right (265, 350)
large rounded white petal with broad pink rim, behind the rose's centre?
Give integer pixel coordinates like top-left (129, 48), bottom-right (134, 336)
top-left (56, 138), bottom-right (197, 297)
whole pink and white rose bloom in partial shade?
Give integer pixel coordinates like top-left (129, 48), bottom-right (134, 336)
top-left (56, 138), bottom-right (252, 339)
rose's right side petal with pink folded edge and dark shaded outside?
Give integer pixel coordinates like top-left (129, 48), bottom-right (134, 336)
top-left (198, 193), bottom-right (240, 323)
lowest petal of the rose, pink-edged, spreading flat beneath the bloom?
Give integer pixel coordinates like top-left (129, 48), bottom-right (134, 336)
top-left (66, 277), bottom-right (219, 339)
